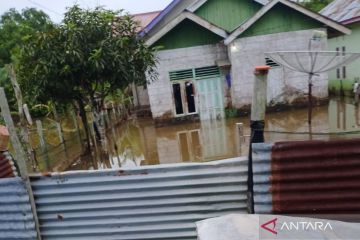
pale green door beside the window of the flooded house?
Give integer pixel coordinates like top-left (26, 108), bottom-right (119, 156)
top-left (196, 77), bottom-right (224, 120)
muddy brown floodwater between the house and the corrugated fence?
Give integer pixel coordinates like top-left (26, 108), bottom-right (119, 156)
top-left (69, 99), bottom-right (360, 170)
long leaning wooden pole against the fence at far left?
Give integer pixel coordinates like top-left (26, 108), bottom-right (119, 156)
top-left (0, 88), bottom-right (41, 240)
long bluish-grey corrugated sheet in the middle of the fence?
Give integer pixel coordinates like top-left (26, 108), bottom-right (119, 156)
top-left (31, 158), bottom-right (248, 240)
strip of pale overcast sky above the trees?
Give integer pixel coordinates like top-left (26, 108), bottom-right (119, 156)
top-left (0, 0), bottom-right (172, 23)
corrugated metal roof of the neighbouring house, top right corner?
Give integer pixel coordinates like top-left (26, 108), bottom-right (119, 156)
top-left (320, 0), bottom-right (360, 24)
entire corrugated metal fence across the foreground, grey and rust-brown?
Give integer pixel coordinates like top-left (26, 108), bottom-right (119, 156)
top-left (0, 139), bottom-right (360, 240)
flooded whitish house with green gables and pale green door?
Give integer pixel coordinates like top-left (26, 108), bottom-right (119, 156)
top-left (141, 0), bottom-right (350, 124)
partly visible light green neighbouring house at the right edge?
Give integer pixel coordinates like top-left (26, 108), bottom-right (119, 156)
top-left (320, 0), bottom-right (360, 93)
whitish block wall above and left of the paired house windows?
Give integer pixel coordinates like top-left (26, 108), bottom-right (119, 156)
top-left (148, 45), bottom-right (227, 119)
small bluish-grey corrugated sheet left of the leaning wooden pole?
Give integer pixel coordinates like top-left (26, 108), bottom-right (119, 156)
top-left (0, 177), bottom-right (36, 240)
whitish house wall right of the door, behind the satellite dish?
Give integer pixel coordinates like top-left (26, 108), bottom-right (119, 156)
top-left (228, 29), bottom-right (328, 108)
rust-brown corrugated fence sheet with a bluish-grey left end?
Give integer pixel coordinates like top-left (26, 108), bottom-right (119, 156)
top-left (253, 139), bottom-right (360, 214)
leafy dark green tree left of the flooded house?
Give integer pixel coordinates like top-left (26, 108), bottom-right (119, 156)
top-left (19, 5), bottom-right (157, 150)
